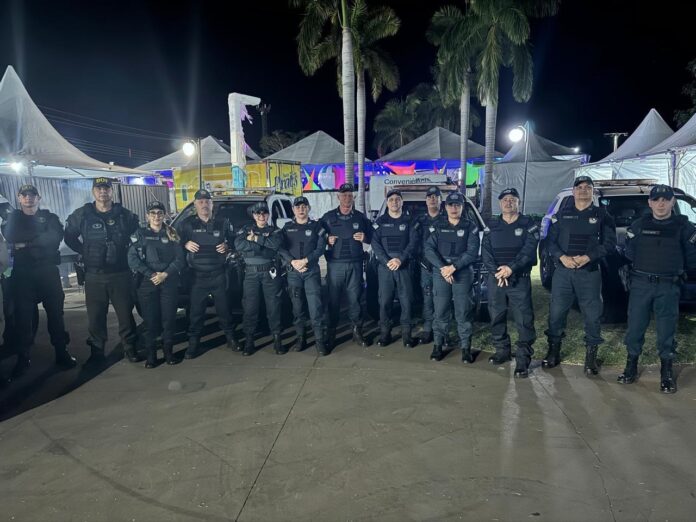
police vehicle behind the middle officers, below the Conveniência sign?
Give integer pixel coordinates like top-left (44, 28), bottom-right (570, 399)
top-left (365, 179), bottom-right (489, 321)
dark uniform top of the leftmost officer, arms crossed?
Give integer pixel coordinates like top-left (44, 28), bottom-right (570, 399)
top-left (5, 209), bottom-right (63, 268)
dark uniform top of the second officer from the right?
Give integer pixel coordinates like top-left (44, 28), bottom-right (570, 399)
top-left (547, 205), bottom-right (616, 270)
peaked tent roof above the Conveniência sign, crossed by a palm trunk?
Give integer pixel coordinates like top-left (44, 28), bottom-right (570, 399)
top-left (378, 127), bottom-right (485, 161)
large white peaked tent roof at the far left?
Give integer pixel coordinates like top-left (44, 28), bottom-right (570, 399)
top-left (0, 66), bottom-right (147, 176)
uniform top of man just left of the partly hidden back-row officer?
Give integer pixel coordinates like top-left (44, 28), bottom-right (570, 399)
top-left (372, 212), bottom-right (420, 266)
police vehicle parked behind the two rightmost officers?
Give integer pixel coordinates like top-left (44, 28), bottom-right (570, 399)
top-left (539, 179), bottom-right (696, 323)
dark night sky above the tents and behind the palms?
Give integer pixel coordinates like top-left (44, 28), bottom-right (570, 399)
top-left (0, 0), bottom-right (696, 166)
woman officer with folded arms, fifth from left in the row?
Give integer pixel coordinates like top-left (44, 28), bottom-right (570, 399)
top-left (234, 201), bottom-right (288, 356)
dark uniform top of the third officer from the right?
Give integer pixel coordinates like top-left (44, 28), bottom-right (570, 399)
top-left (481, 214), bottom-right (539, 274)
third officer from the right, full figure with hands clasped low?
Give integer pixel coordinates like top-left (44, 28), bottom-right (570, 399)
top-left (481, 188), bottom-right (539, 378)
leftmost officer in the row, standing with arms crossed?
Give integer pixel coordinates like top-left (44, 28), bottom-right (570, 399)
top-left (5, 185), bottom-right (77, 379)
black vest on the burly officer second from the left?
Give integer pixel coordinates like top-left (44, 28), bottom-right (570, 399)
top-left (81, 204), bottom-right (129, 269)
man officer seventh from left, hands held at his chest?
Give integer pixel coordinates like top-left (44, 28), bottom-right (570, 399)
top-left (321, 183), bottom-right (372, 348)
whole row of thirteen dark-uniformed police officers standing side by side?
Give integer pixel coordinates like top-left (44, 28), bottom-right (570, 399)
top-left (4, 176), bottom-right (696, 393)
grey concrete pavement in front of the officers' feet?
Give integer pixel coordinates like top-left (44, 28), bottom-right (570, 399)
top-left (0, 290), bottom-right (696, 521)
